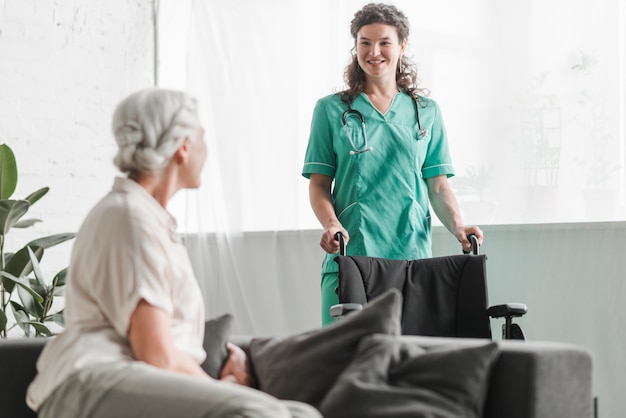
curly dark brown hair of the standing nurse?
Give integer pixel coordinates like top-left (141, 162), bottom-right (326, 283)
top-left (339, 3), bottom-right (425, 102)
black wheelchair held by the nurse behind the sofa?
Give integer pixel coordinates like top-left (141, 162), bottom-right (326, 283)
top-left (330, 233), bottom-right (528, 340)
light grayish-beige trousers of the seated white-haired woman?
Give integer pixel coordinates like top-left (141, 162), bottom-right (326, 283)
top-left (37, 361), bottom-right (322, 418)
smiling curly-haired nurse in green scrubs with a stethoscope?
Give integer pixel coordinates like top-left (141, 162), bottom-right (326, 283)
top-left (302, 4), bottom-right (483, 325)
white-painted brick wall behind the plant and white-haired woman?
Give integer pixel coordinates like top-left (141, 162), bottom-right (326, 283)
top-left (0, 0), bottom-right (154, 274)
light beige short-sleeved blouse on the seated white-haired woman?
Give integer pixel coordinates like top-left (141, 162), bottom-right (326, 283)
top-left (26, 177), bottom-right (206, 410)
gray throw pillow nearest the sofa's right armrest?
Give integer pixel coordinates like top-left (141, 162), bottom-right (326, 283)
top-left (319, 335), bottom-right (499, 418)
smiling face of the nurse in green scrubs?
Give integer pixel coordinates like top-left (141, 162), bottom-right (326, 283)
top-left (356, 23), bottom-right (406, 80)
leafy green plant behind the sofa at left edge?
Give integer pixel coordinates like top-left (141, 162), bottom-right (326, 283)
top-left (0, 144), bottom-right (75, 338)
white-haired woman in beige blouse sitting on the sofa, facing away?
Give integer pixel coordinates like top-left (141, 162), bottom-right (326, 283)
top-left (27, 88), bottom-right (320, 418)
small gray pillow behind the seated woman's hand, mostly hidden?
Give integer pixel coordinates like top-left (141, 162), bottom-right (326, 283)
top-left (202, 313), bottom-right (233, 379)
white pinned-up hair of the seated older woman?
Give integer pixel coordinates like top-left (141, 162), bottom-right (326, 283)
top-left (112, 88), bottom-right (200, 173)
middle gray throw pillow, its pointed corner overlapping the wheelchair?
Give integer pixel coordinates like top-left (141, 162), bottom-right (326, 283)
top-left (248, 289), bottom-right (402, 406)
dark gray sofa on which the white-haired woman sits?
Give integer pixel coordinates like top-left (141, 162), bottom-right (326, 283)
top-left (0, 336), bottom-right (593, 418)
